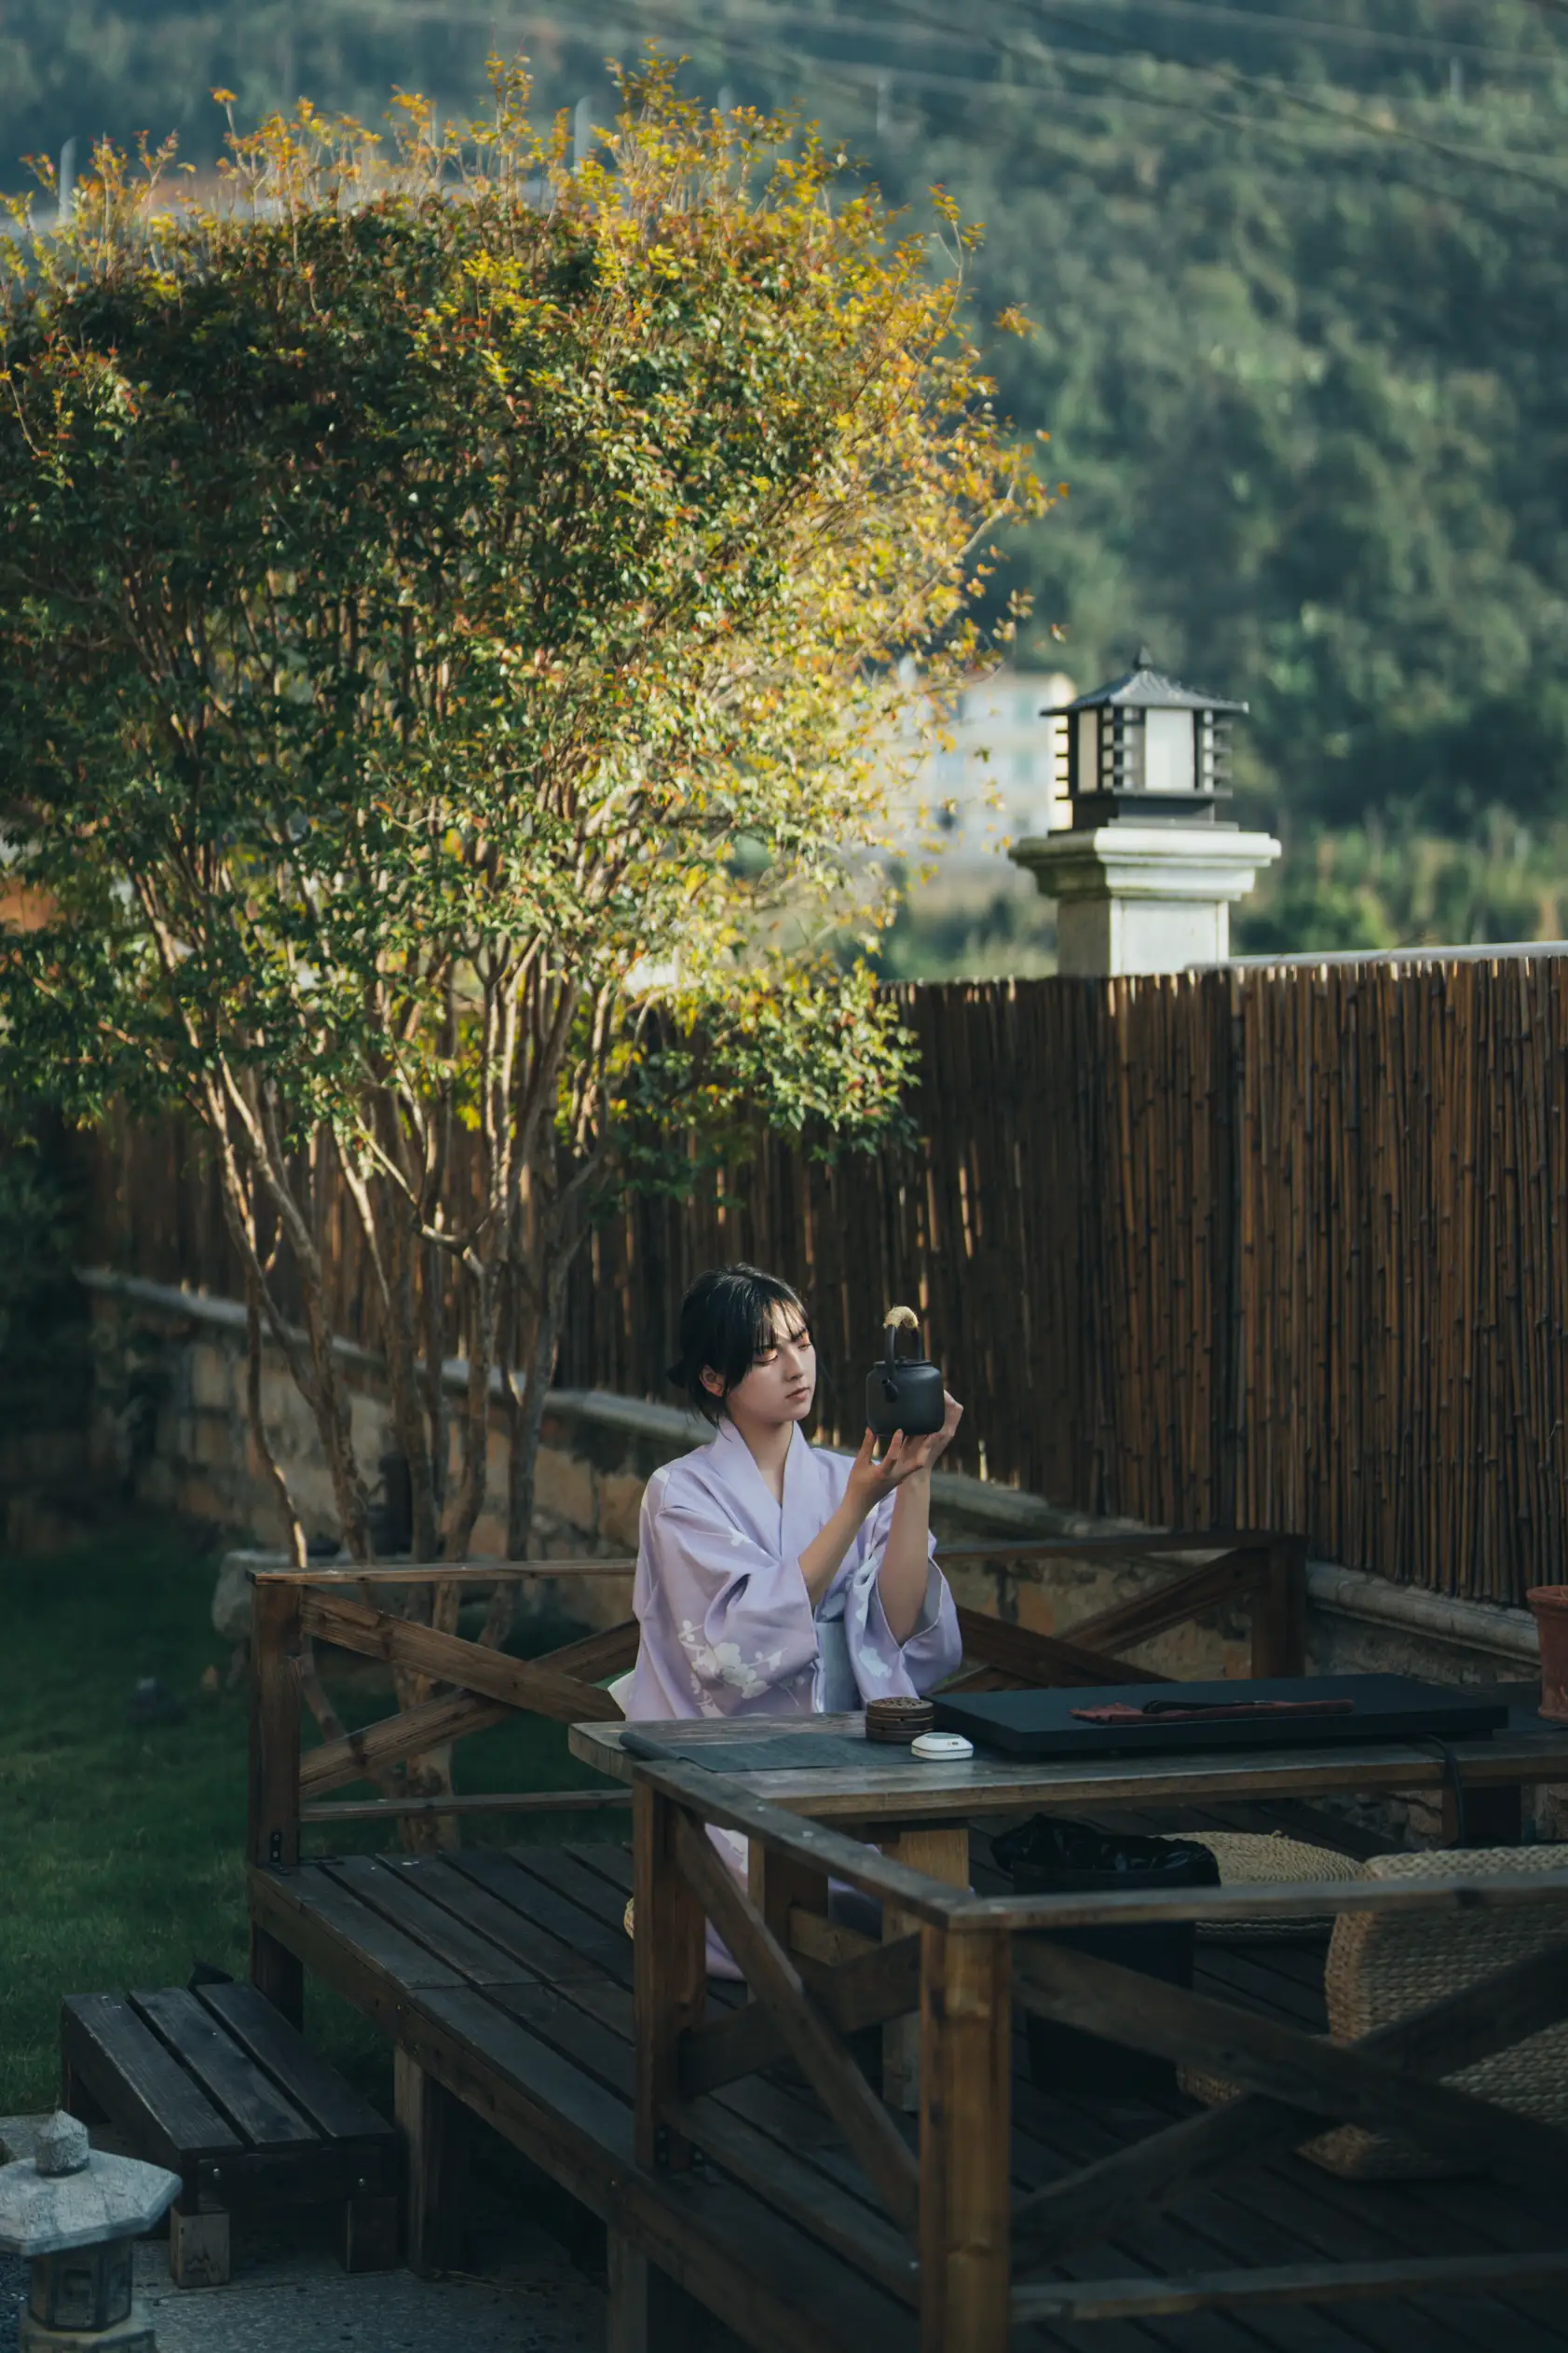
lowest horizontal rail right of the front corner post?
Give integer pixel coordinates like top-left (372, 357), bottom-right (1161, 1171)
top-left (1014, 2247), bottom-right (1568, 2327)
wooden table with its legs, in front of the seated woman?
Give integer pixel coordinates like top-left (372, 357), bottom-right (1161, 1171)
top-left (569, 1685), bottom-right (1568, 2108)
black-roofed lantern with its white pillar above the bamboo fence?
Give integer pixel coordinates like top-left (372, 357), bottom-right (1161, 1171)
top-left (1008, 647), bottom-right (1279, 974)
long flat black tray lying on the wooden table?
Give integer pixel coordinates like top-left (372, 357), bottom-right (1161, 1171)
top-left (935, 1676), bottom-right (1509, 1758)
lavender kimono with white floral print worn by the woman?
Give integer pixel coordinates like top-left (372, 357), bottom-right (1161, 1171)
top-left (616, 1421), bottom-right (961, 1720)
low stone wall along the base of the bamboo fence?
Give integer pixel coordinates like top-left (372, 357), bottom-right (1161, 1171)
top-left (61, 1276), bottom-right (1535, 1769)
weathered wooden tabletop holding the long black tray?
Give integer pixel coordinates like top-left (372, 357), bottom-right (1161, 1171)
top-left (571, 1687), bottom-right (1568, 1821)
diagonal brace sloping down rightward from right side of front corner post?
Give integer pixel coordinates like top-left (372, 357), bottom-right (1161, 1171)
top-left (1014, 1944), bottom-right (1568, 2186)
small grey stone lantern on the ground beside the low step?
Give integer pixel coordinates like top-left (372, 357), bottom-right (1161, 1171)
top-left (0, 2111), bottom-right (179, 2353)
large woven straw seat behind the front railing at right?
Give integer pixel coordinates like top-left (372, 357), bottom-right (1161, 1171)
top-left (1182, 1847), bottom-right (1568, 2182)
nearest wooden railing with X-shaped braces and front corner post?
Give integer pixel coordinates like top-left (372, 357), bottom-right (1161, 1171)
top-left (633, 1765), bottom-right (1568, 2353)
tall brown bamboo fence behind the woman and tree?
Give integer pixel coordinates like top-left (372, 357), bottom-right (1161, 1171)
top-left (76, 958), bottom-right (1568, 1603)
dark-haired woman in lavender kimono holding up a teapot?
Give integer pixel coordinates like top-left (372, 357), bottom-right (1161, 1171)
top-left (616, 1265), bottom-right (961, 1720)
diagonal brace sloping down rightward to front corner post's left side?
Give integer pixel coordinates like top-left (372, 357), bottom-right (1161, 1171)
top-left (675, 1812), bottom-right (920, 2231)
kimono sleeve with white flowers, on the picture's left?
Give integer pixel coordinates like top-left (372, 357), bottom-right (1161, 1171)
top-left (644, 1498), bottom-right (818, 1716)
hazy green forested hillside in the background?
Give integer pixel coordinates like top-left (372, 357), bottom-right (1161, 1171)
top-left (0, 0), bottom-right (1568, 946)
